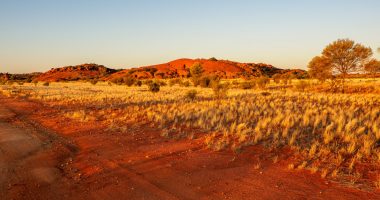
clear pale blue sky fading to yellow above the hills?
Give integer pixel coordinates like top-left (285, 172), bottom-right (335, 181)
top-left (0, 0), bottom-right (380, 73)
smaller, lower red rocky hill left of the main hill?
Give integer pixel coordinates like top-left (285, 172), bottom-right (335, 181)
top-left (34, 64), bottom-right (117, 82)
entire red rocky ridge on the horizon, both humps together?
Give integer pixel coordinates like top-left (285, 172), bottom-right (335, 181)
top-left (34, 58), bottom-right (307, 82)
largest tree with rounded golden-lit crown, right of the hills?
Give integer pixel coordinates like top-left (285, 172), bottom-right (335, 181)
top-left (309, 39), bottom-right (373, 92)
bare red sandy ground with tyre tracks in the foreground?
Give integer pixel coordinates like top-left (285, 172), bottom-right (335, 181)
top-left (0, 97), bottom-right (380, 200)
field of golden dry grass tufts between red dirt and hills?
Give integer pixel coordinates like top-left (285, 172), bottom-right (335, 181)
top-left (0, 79), bottom-right (380, 187)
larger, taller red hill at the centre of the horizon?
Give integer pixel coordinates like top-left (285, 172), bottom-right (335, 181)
top-left (106, 58), bottom-right (307, 80)
